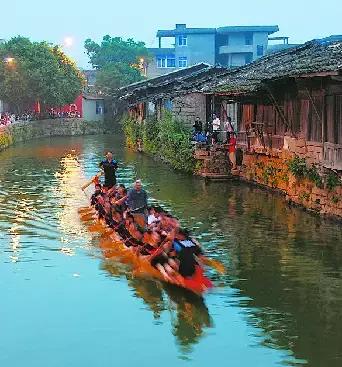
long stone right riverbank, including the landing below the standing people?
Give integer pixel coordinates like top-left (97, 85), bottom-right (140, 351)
top-left (125, 128), bottom-right (342, 222)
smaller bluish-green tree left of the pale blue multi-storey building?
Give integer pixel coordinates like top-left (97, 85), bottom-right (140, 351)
top-left (84, 35), bottom-right (149, 93)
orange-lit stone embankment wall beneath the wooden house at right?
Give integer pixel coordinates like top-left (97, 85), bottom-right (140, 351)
top-left (239, 138), bottom-right (342, 219)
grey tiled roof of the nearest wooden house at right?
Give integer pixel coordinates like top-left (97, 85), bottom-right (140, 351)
top-left (200, 36), bottom-right (342, 94)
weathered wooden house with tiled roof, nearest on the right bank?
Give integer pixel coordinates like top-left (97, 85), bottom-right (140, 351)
top-left (202, 37), bottom-right (342, 170)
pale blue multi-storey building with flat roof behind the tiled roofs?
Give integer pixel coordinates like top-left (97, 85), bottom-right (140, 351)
top-left (147, 24), bottom-right (279, 78)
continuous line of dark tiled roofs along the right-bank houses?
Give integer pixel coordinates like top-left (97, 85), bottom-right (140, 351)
top-left (113, 36), bottom-right (342, 105)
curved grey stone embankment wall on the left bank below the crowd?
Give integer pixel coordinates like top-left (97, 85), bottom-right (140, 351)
top-left (0, 119), bottom-right (106, 151)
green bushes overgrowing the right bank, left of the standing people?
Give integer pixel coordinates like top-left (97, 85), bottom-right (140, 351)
top-left (123, 111), bottom-right (196, 172)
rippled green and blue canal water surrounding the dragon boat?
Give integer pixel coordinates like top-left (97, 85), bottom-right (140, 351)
top-left (0, 135), bottom-right (342, 367)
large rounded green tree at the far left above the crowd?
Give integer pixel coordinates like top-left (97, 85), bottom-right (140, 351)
top-left (0, 37), bottom-right (84, 113)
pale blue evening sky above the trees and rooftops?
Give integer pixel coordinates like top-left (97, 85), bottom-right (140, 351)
top-left (0, 0), bottom-right (342, 68)
